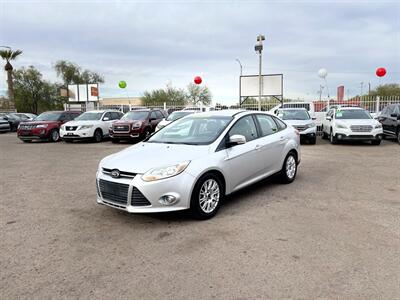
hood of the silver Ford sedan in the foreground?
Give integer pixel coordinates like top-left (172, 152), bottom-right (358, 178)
top-left (100, 143), bottom-right (209, 174)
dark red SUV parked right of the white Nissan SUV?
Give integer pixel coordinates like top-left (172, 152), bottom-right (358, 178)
top-left (110, 109), bottom-right (164, 142)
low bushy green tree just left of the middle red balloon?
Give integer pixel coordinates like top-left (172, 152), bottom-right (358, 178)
top-left (142, 85), bottom-right (186, 106)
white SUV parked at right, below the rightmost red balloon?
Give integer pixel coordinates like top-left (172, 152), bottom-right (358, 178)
top-left (322, 107), bottom-right (383, 145)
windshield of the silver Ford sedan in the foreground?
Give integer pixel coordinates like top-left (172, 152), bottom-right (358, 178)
top-left (148, 115), bottom-right (232, 145)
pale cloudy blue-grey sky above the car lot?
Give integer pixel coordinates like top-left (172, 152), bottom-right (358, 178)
top-left (0, 0), bottom-right (400, 103)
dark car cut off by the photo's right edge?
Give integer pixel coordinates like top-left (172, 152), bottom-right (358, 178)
top-left (378, 104), bottom-right (400, 144)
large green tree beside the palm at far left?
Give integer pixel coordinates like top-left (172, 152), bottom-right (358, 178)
top-left (13, 66), bottom-right (62, 114)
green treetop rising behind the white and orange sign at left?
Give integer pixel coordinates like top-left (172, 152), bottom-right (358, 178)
top-left (54, 60), bottom-right (104, 86)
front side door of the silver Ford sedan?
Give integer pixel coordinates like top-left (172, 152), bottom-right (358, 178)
top-left (223, 115), bottom-right (263, 191)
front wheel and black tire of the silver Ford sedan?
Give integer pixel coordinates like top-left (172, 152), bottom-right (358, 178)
top-left (190, 173), bottom-right (225, 220)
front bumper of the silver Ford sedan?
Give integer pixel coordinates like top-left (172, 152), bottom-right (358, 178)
top-left (96, 171), bottom-right (195, 213)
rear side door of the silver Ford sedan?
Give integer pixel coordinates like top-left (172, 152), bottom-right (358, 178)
top-left (256, 114), bottom-right (288, 175)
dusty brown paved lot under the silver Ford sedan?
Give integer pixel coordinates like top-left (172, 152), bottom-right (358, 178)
top-left (0, 133), bottom-right (400, 299)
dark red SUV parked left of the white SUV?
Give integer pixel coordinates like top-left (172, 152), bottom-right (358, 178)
top-left (17, 111), bottom-right (81, 142)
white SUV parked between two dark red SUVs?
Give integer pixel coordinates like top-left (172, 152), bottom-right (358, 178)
top-left (60, 110), bottom-right (123, 142)
